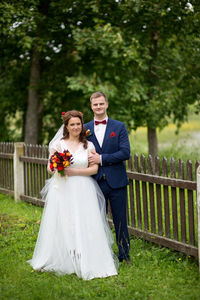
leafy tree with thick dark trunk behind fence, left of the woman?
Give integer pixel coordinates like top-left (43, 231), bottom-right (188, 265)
top-left (0, 0), bottom-right (96, 143)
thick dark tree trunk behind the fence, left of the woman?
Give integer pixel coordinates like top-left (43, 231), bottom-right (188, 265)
top-left (25, 48), bottom-right (40, 144)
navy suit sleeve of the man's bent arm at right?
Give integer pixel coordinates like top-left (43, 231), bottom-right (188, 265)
top-left (102, 124), bottom-right (130, 166)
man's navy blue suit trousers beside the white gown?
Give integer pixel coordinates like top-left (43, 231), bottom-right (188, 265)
top-left (98, 178), bottom-right (130, 261)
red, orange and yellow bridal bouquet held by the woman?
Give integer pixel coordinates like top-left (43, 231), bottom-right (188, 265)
top-left (50, 150), bottom-right (73, 176)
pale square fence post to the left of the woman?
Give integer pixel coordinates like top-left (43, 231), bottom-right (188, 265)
top-left (13, 143), bottom-right (24, 202)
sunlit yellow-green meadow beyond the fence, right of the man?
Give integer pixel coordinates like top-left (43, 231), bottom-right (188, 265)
top-left (130, 114), bottom-right (200, 162)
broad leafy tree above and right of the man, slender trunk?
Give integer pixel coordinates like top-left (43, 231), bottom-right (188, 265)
top-left (67, 0), bottom-right (199, 157)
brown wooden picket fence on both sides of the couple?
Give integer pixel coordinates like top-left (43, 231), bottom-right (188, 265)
top-left (0, 143), bottom-right (199, 262)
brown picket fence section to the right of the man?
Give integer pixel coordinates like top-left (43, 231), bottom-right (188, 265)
top-left (127, 154), bottom-right (199, 256)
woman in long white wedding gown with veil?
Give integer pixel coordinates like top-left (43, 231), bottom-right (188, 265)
top-left (28, 110), bottom-right (117, 280)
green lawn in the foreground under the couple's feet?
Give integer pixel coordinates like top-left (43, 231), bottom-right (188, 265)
top-left (0, 195), bottom-right (200, 300)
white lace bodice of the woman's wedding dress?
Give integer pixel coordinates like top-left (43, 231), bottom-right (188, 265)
top-left (52, 140), bottom-right (95, 168)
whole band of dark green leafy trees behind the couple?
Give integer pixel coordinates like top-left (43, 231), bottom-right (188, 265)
top-left (0, 0), bottom-right (200, 154)
